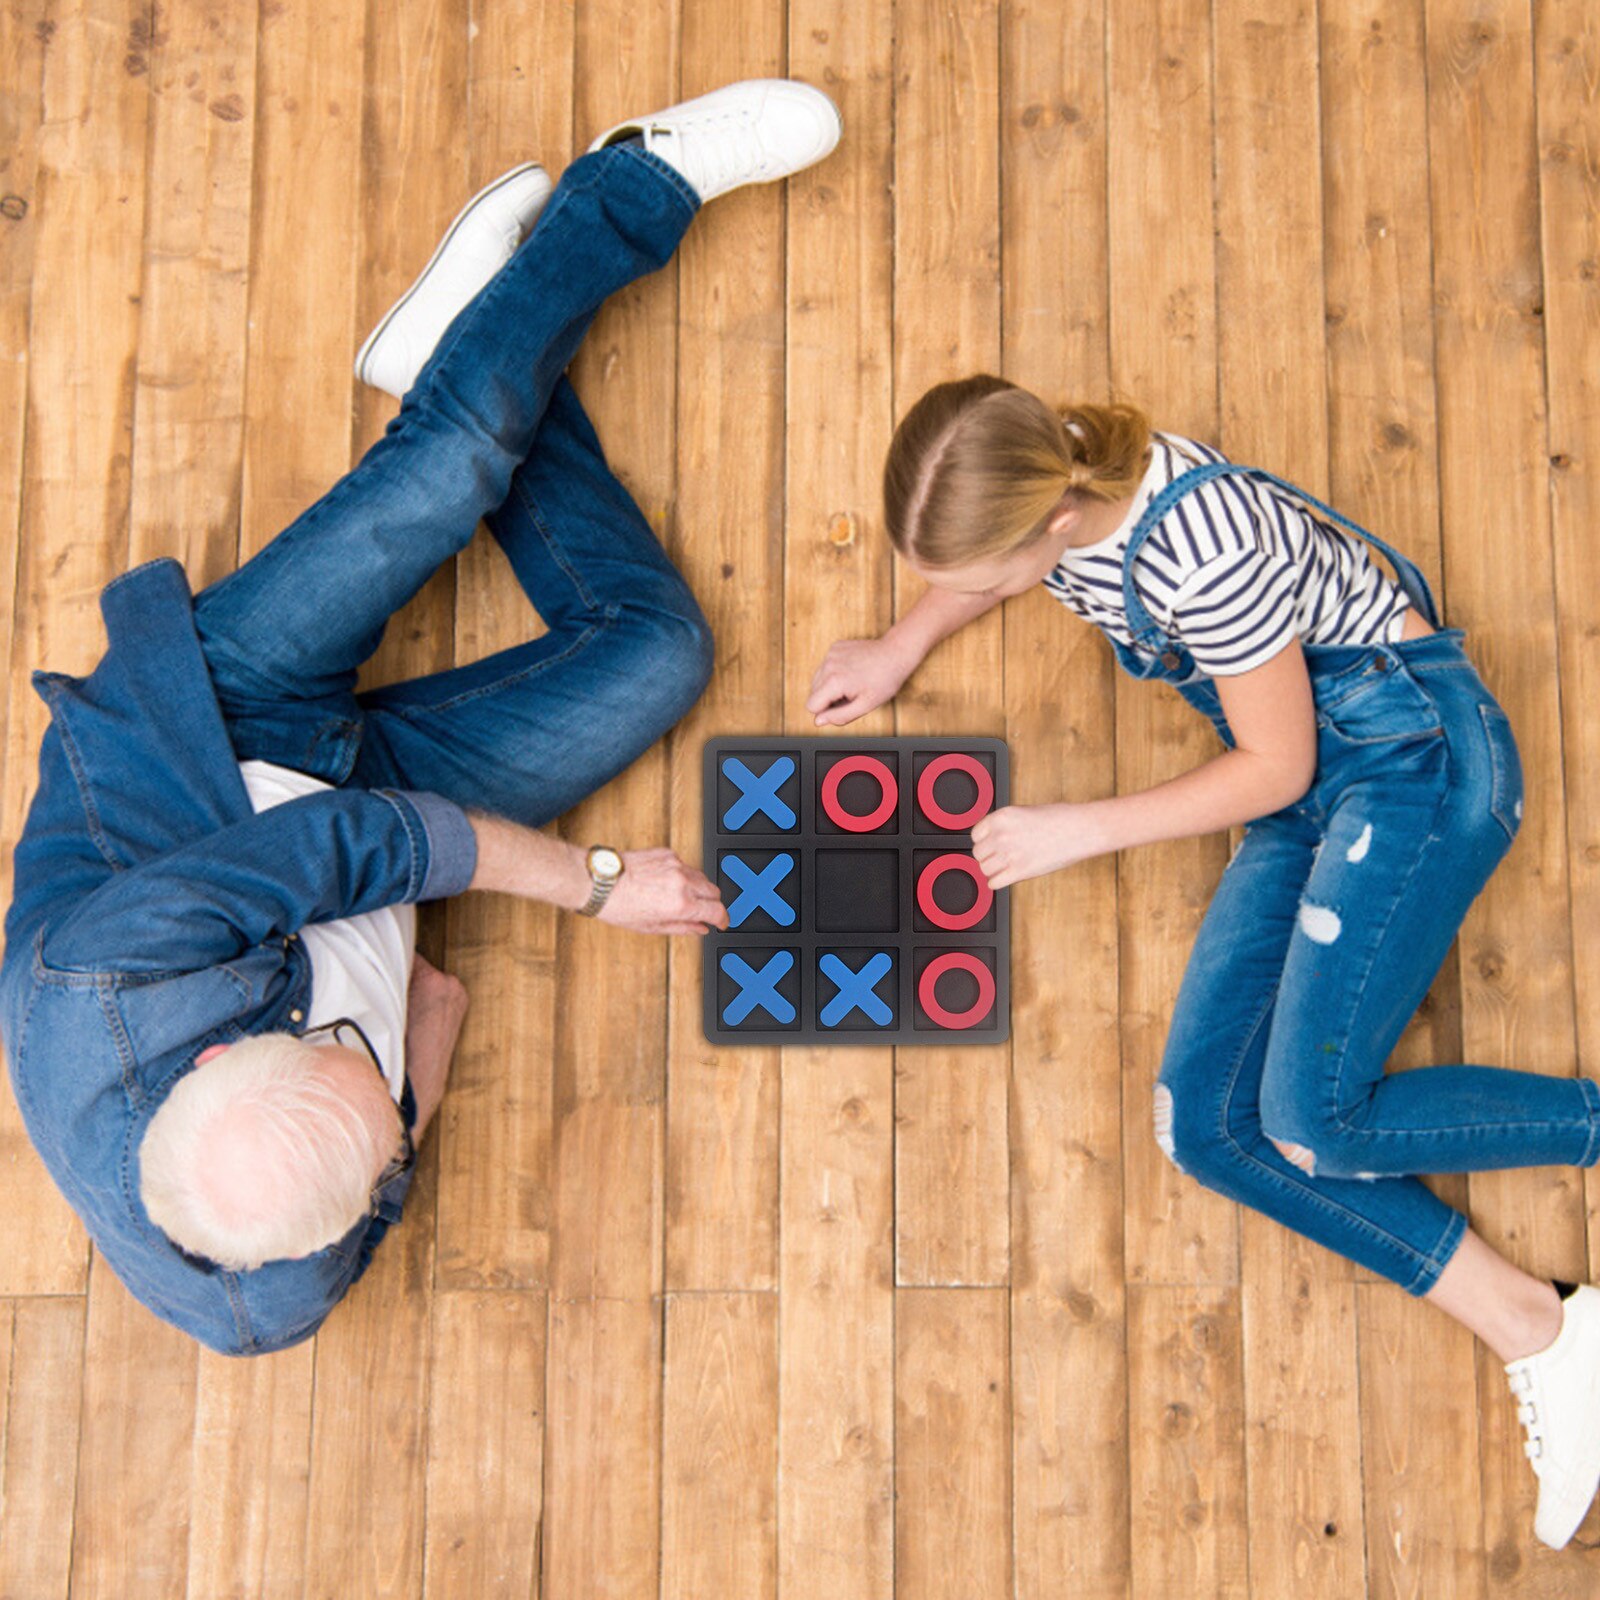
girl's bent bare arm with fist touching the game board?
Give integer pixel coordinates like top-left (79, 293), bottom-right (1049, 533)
top-left (973, 640), bottom-right (1317, 890)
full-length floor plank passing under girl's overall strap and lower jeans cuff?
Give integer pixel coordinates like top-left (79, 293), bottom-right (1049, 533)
top-left (1322, 0), bottom-right (1485, 1597)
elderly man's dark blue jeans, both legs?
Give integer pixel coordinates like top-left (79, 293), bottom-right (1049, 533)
top-left (195, 146), bottom-right (712, 824)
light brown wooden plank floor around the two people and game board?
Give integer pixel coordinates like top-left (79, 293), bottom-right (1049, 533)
top-left (0, 0), bottom-right (1600, 1600)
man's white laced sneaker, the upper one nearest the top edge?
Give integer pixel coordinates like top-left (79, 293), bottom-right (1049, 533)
top-left (589, 78), bottom-right (843, 200)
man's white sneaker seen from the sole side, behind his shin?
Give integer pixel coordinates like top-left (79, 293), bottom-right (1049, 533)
top-left (355, 162), bottom-right (555, 398)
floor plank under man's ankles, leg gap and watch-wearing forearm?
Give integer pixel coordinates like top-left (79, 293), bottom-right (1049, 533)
top-left (438, 0), bottom-right (573, 1288)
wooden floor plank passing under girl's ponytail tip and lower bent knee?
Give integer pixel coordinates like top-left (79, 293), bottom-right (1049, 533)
top-left (1106, 0), bottom-right (1238, 1283)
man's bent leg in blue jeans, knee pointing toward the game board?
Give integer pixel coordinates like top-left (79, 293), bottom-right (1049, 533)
top-left (350, 379), bottom-right (712, 826)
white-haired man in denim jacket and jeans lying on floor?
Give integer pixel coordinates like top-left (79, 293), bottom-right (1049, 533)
top-left (0, 82), bottom-right (838, 1354)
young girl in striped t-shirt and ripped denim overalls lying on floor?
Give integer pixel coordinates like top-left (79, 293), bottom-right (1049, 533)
top-left (806, 376), bottom-right (1600, 1547)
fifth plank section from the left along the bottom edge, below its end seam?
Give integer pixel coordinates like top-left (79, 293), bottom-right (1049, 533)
top-left (424, 1291), bottom-right (547, 1600)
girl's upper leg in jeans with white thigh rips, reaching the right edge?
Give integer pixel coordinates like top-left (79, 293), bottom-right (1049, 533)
top-left (1261, 670), bottom-right (1600, 1176)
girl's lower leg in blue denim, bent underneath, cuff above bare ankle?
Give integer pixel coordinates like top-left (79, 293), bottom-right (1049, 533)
top-left (1155, 813), bottom-right (1466, 1294)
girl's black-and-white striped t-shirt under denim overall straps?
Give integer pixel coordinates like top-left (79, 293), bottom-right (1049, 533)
top-left (1045, 434), bottom-right (1410, 677)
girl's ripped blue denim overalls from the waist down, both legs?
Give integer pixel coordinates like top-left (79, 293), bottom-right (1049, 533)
top-left (1157, 629), bottom-right (1600, 1294)
